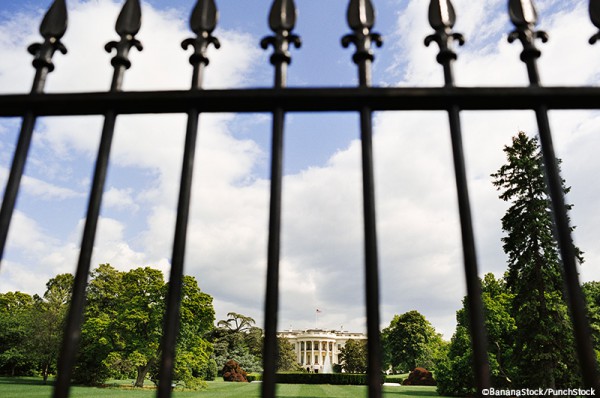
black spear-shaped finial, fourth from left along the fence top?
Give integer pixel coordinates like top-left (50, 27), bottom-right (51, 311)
top-left (260, 0), bottom-right (302, 66)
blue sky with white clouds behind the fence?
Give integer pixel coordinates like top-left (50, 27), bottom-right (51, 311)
top-left (0, 0), bottom-right (600, 338)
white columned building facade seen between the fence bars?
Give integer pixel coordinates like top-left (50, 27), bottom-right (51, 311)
top-left (277, 329), bottom-right (367, 373)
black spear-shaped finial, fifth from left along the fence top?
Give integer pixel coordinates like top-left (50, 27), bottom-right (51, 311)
top-left (342, 0), bottom-right (383, 68)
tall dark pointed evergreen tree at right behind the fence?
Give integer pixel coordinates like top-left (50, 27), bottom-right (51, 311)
top-left (492, 132), bottom-right (582, 388)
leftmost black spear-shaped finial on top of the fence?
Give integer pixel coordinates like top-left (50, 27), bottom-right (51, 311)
top-left (27, 0), bottom-right (68, 72)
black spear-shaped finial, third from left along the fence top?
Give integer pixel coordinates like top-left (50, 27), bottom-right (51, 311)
top-left (181, 0), bottom-right (221, 67)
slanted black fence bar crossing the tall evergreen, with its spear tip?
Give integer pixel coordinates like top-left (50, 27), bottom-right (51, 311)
top-left (508, 0), bottom-right (600, 388)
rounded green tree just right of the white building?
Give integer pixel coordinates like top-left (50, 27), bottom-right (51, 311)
top-left (382, 310), bottom-right (444, 371)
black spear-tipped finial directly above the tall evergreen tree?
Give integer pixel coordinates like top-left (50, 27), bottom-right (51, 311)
top-left (508, 0), bottom-right (548, 62)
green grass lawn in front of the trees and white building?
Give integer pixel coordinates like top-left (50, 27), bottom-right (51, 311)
top-left (0, 377), bottom-right (450, 398)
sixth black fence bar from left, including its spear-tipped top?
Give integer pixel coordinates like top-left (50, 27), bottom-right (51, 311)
top-left (425, 0), bottom-right (490, 396)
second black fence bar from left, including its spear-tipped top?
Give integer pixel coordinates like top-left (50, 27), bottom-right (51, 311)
top-left (54, 0), bottom-right (142, 398)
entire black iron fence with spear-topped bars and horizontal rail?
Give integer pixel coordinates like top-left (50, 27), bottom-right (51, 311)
top-left (0, 0), bottom-right (600, 398)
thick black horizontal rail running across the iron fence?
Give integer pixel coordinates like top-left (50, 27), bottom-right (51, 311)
top-left (0, 87), bottom-right (600, 113)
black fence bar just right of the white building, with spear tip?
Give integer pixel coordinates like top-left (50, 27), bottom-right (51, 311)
top-left (342, 0), bottom-right (383, 398)
